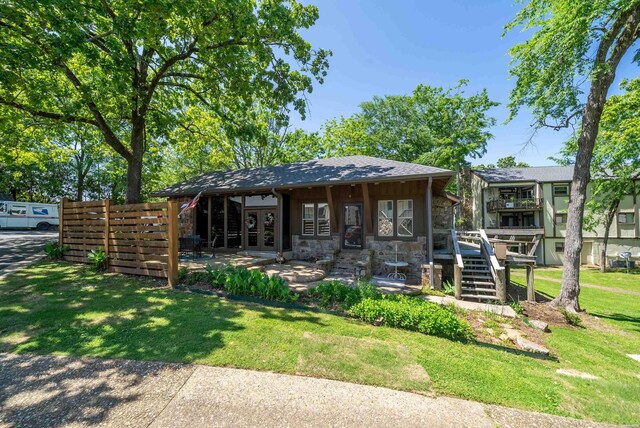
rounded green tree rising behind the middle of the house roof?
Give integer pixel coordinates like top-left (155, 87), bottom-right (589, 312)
top-left (322, 80), bottom-right (498, 169)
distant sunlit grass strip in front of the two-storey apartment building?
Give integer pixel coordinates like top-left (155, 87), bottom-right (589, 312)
top-left (512, 268), bottom-right (640, 292)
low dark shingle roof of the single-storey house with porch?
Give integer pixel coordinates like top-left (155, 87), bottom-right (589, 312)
top-left (154, 156), bottom-right (454, 197)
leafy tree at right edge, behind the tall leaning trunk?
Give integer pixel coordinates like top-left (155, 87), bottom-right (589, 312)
top-left (561, 79), bottom-right (640, 272)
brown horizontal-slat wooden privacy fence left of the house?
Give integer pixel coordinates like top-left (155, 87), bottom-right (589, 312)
top-left (59, 199), bottom-right (178, 286)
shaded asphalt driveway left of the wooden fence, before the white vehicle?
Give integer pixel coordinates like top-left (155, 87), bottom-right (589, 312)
top-left (0, 230), bottom-right (58, 278)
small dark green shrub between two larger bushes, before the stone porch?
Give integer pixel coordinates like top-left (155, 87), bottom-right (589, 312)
top-left (309, 280), bottom-right (380, 309)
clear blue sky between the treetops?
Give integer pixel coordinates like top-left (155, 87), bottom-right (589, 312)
top-left (294, 0), bottom-right (637, 165)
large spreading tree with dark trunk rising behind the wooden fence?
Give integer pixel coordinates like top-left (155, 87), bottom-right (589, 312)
top-left (0, 0), bottom-right (330, 202)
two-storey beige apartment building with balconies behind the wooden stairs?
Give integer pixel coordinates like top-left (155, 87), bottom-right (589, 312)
top-left (471, 166), bottom-right (640, 265)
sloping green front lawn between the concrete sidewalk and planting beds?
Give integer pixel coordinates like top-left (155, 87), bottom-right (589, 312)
top-left (0, 262), bottom-right (640, 424)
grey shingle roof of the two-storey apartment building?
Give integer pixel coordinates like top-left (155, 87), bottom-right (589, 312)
top-left (473, 165), bottom-right (573, 183)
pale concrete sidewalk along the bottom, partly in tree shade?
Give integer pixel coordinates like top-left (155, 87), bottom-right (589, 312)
top-left (0, 354), bottom-right (603, 427)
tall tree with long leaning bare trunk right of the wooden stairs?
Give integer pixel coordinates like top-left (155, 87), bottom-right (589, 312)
top-left (505, 0), bottom-right (640, 311)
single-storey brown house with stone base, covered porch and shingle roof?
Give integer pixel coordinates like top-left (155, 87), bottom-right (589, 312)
top-left (154, 156), bottom-right (457, 280)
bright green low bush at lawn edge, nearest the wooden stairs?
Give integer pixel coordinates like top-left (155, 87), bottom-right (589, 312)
top-left (350, 296), bottom-right (473, 340)
